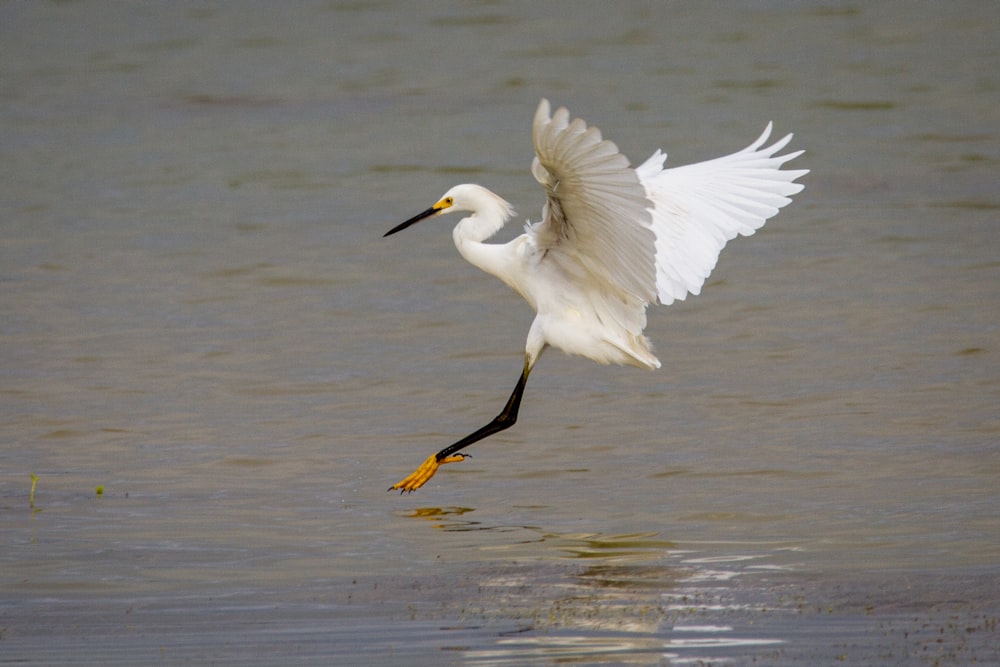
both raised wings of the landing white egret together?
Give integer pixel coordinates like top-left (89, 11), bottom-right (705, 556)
top-left (527, 99), bottom-right (808, 354)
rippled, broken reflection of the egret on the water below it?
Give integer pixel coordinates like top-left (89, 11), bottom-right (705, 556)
top-left (386, 506), bottom-right (808, 664)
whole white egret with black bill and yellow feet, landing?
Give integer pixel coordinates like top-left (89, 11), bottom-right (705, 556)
top-left (385, 99), bottom-right (808, 493)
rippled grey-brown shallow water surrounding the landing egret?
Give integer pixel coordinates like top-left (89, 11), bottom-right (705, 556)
top-left (0, 2), bottom-right (1000, 665)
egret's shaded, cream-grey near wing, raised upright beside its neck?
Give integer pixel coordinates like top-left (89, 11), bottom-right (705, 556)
top-left (529, 99), bottom-right (656, 308)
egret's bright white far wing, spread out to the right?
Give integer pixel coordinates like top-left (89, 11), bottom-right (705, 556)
top-left (636, 123), bottom-right (809, 304)
